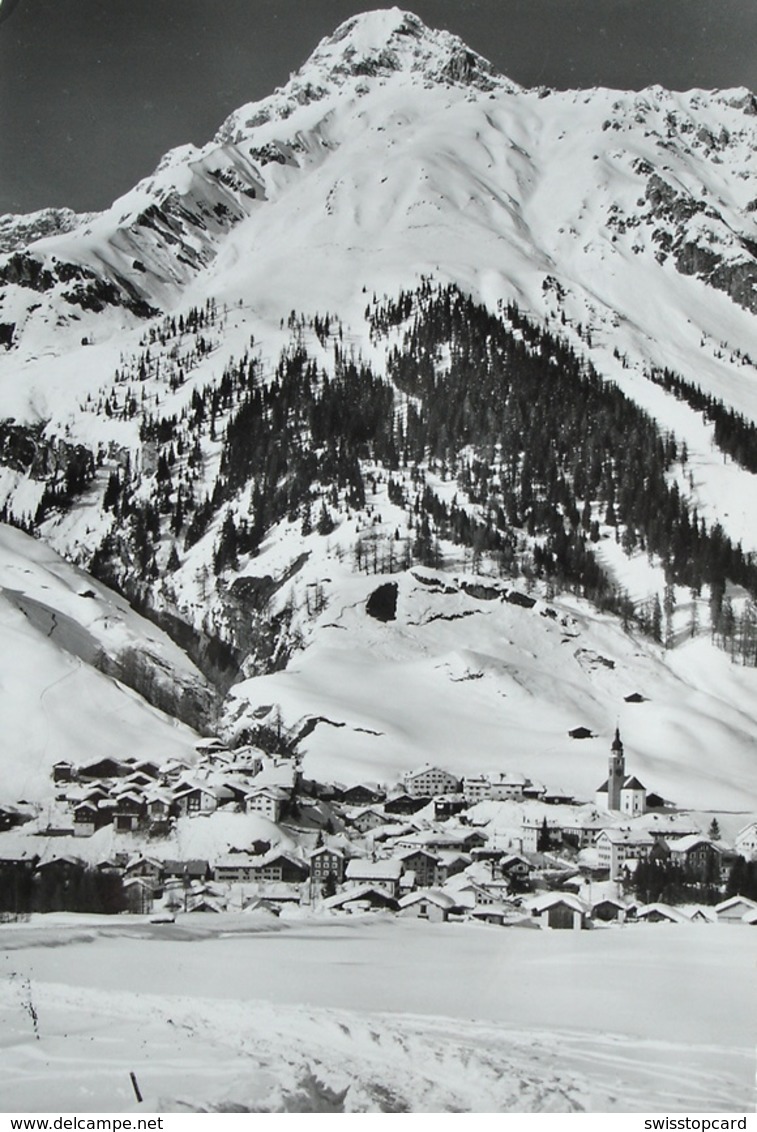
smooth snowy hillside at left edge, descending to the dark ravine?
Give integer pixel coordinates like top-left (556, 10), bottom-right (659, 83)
top-left (0, 526), bottom-right (212, 803)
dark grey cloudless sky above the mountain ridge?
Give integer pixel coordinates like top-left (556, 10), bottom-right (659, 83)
top-left (0, 0), bottom-right (757, 213)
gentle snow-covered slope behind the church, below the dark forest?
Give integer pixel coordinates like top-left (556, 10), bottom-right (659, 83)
top-left (225, 547), bottom-right (757, 809)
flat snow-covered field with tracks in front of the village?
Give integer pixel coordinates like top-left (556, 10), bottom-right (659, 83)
top-left (0, 916), bottom-right (757, 1112)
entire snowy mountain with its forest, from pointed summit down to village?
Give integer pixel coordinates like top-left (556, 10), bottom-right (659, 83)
top-left (0, 8), bottom-right (757, 806)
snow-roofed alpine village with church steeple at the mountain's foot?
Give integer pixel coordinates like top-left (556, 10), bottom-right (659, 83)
top-left (0, 730), bottom-right (757, 929)
